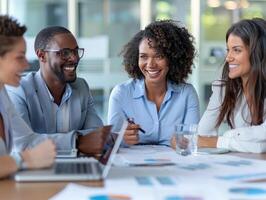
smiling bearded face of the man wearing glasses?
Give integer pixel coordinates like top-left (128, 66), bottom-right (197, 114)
top-left (44, 33), bottom-right (79, 84)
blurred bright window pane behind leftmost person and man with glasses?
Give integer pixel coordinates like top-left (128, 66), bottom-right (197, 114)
top-left (8, 0), bottom-right (68, 71)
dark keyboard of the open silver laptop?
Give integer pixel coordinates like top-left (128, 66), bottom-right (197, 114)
top-left (55, 162), bottom-right (96, 174)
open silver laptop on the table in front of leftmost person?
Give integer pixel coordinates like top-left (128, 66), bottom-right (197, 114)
top-left (14, 121), bottom-right (127, 182)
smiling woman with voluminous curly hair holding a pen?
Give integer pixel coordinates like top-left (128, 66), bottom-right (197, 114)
top-left (108, 20), bottom-right (199, 145)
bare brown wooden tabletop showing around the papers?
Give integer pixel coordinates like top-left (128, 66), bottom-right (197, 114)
top-left (0, 153), bottom-right (266, 200)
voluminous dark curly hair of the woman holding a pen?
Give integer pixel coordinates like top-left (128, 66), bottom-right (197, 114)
top-left (120, 20), bottom-right (196, 84)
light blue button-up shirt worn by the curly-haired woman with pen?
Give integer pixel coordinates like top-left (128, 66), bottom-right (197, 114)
top-left (108, 79), bottom-right (200, 145)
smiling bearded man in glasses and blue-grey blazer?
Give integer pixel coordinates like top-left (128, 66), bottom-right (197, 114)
top-left (7, 26), bottom-right (109, 154)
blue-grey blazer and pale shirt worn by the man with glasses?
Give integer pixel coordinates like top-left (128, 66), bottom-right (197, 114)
top-left (7, 71), bottom-right (103, 149)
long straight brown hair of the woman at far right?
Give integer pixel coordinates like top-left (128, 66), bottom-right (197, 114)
top-left (216, 18), bottom-right (266, 128)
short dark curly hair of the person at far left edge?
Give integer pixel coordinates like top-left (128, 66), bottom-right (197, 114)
top-left (0, 15), bottom-right (27, 56)
